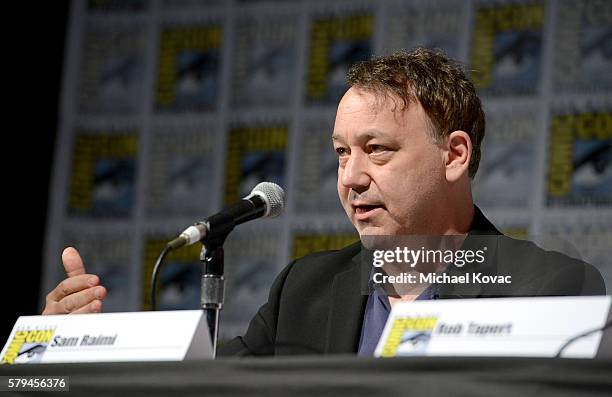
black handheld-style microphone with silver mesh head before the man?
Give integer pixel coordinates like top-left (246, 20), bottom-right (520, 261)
top-left (168, 182), bottom-right (285, 249)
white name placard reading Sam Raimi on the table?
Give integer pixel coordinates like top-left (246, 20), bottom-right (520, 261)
top-left (0, 310), bottom-right (212, 364)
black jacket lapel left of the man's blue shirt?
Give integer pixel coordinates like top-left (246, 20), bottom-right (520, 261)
top-left (325, 251), bottom-right (370, 354)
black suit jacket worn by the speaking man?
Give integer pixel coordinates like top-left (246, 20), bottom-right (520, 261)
top-left (218, 207), bottom-right (606, 356)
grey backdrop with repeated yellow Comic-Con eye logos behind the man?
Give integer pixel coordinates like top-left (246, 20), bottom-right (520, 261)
top-left (41, 0), bottom-right (612, 338)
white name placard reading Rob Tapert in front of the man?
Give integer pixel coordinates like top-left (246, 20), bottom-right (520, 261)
top-left (374, 296), bottom-right (611, 358)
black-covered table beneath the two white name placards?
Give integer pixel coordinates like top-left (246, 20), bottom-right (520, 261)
top-left (0, 356), bottom-right (612, 397)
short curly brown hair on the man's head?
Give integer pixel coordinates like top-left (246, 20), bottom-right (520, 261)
top-left (347, 47), bottom-right (485, 178)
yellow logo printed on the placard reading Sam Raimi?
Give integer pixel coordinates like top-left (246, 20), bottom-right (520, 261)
top-left (2, 328), bottom-right (55, 364)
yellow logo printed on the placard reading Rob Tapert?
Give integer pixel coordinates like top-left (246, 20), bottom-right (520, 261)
top-left (381, 316), bottom-right (438, 357)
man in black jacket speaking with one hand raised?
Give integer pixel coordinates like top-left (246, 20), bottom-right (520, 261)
top-left (43, 48), bottom-right (605, 355)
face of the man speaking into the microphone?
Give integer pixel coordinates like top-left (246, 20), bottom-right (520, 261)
top-left (332, 87), bottom-right (446, 237)
